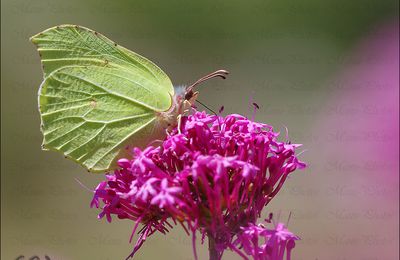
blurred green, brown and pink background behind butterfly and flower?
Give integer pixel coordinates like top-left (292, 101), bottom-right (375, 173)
top-left (1, 0), bottom-right (399, 260)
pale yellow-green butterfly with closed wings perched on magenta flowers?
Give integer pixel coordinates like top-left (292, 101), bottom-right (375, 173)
top-left (31, 25), bottom-right (228, 172)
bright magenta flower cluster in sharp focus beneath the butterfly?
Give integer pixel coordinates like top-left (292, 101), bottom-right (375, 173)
top-left (91, 112), bottom-right (305, 259)
